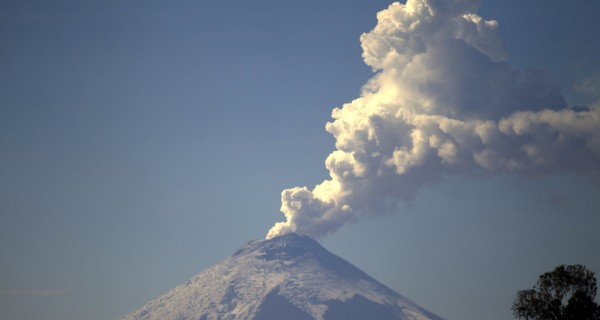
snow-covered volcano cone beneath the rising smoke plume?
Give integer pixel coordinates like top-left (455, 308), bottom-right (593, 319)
top-left (121, 234), bottom-right (443, 320)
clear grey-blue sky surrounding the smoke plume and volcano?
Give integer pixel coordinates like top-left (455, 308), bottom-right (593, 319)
top-left (0, 0), bottom-right (600, 320)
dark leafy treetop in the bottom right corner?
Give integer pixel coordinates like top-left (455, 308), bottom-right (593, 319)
top-left (512, 265), bottom-right (600, 320)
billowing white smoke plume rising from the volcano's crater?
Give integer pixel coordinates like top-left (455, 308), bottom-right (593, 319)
top-left (267, 0), bottom-right (600, 238)
